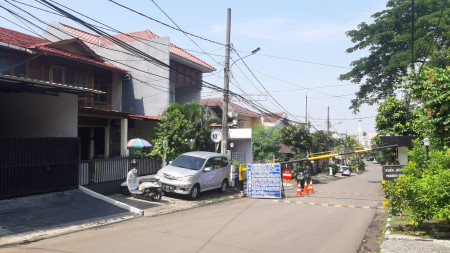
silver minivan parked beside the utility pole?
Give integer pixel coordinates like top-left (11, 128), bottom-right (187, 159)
top-left (156, 151), bottom-right (231, 199)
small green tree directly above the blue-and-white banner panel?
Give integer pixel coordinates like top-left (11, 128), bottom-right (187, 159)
top-left (252, 125), bottom-right (281, 161)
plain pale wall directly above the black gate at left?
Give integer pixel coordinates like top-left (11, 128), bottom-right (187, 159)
top-left (0, 92), bottom-right (78, 137)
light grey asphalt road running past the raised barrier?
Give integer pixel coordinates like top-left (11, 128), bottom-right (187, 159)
top-left (1, 162), bottom-right (383, 253)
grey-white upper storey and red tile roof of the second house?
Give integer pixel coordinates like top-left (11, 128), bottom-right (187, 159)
top-left (42, 22), bottom-right (215, 116)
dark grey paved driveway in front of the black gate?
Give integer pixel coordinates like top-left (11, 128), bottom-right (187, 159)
top-left (0, 190), bottom-right (139, 248)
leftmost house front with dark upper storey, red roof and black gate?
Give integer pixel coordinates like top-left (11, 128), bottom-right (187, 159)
top-left (0, 27), bottom-right (126, 198)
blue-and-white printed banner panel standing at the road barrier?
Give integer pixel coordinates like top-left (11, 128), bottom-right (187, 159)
top-left (247, 163), bottom-right (281, 198)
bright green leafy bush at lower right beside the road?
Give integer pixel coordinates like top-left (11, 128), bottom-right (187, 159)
top-left (383, 140), bottom-right (450, 225)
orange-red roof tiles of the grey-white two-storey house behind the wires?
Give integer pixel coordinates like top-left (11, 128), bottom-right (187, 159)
top-left (61, 24), bottom-right (216, 71)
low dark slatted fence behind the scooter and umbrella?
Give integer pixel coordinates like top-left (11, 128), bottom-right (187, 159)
top-left (79, 157), bottom-right (161, 185)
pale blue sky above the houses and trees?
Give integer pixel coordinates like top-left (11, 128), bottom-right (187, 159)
top-left (0, 0), bottom-right (386, 134)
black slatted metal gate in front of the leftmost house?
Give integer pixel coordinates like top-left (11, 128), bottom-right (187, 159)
top-left (0, 138), bottom-right (79, 199)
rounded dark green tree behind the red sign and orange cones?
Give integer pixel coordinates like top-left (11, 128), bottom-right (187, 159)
top-left (281, 124), bottom-right (312, 158)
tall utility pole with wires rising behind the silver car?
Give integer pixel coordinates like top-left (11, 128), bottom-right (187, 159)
top-left (221, 8), bottom-right (231, 155)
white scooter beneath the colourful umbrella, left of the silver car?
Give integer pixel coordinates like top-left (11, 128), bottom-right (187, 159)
top-left (121, 161), bottom-right (164, 202)
